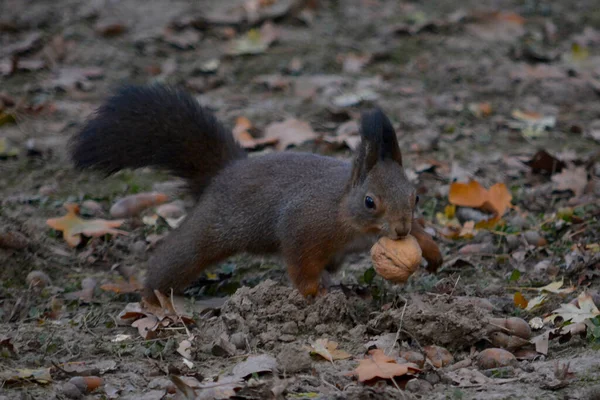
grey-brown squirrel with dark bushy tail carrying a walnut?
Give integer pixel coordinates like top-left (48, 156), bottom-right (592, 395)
top-left (70, 84), bottom-right (442, 299)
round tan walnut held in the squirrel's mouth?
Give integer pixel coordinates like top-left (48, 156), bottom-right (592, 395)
top-left (371, 235), bottom-right (422, 283)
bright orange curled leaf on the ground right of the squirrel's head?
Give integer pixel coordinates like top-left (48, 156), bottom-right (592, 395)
top-left (448, 181), bottom-right (512, 216)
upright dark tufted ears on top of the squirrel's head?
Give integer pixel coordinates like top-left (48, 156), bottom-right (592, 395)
top-left (352, 108), bottom-right (402, 184)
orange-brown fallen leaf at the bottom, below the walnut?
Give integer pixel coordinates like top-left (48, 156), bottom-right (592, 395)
top-left (352, 349), bottom-right (420, 382)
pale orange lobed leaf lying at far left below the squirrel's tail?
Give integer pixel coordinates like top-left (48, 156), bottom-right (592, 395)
top-left (46, 203), bottom-right (127, 247)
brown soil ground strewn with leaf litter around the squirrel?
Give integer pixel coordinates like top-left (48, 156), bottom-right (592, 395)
top-left (0, 0), bottom-right (600, 399)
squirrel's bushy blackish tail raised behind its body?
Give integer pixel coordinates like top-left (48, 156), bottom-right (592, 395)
top-left (70, 85), bottom-right (246, 196)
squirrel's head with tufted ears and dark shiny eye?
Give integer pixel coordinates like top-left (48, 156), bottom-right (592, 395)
top-left (345, 109), bottom-right (418, 239)
